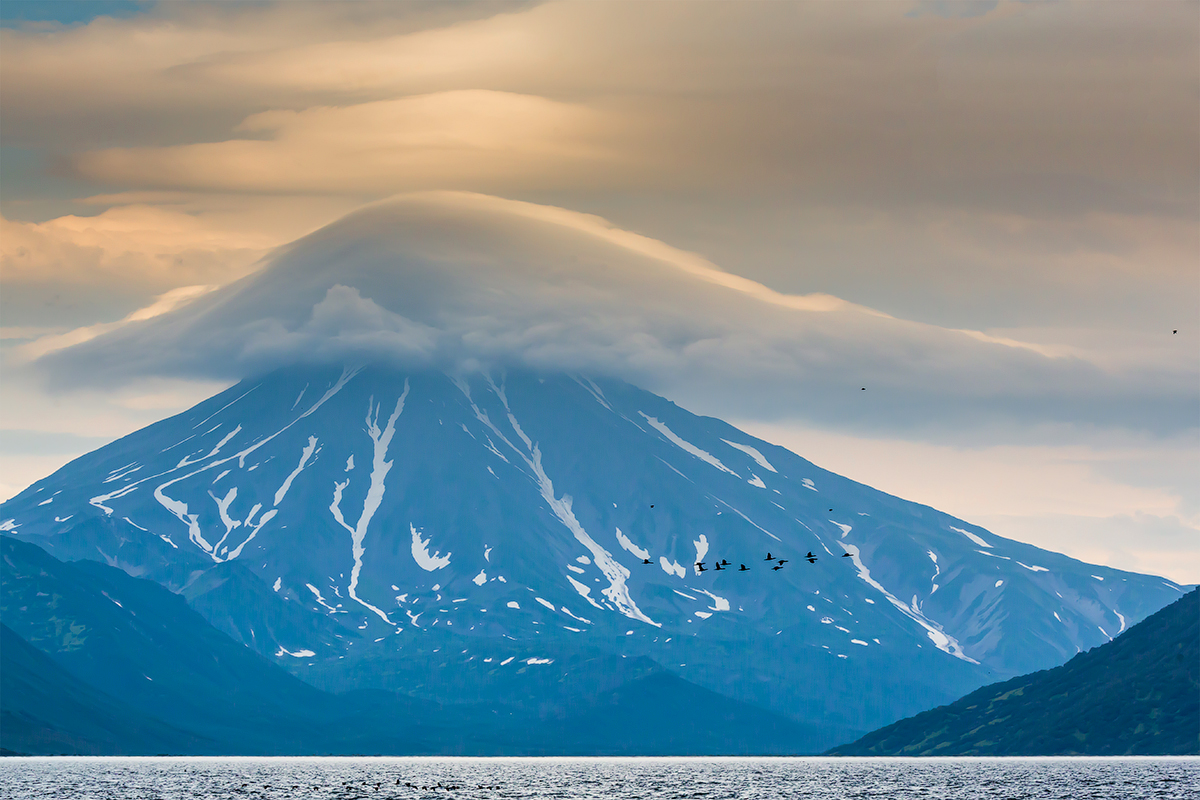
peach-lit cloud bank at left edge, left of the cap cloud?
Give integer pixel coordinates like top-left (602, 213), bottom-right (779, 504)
top-left (0, 192), bottom-right (361, 328)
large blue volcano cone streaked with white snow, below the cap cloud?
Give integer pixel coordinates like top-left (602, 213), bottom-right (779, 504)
top-left (0, 366), bottom-right (1183, 747)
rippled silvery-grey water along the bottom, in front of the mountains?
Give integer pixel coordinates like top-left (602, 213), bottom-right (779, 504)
top-left (0, 758), bottom-right (1200, 800)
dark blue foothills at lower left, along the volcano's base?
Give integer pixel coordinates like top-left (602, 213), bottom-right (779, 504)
top-left (0, 536), bottom-right (830, 756)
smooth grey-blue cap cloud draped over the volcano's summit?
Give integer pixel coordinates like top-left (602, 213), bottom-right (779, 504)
top-left (30, 192), bottom-right (1196, 443)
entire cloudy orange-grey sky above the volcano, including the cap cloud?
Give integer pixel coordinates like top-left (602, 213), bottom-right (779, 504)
top-left (0, 0), bottom-right (1200, 583)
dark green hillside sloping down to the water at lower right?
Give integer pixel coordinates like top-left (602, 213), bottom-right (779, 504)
top-left (832, 589), bottom-right (1200, 756)
